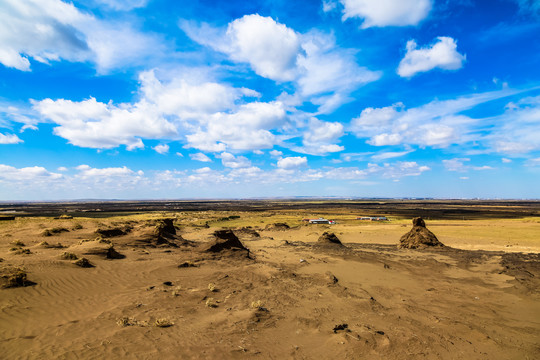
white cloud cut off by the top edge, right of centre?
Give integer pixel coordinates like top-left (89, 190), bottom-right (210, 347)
top-left (340, 0), bottom-right (432, 29)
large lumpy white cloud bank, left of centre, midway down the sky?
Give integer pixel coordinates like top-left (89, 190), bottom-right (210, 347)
top-left (33, 71), bottom-right (266, 151)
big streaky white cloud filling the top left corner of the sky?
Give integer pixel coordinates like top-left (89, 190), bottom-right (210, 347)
top-left (0, 0), bottom-right (164, 72)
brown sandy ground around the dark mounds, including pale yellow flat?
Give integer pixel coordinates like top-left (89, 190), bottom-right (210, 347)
top-left (0, 213), bottom-right (540, 359)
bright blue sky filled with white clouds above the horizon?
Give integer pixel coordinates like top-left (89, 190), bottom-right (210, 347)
top-left (0, 0), bottom-right (540, 200)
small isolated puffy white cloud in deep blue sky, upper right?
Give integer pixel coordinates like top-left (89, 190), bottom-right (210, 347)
top-left (397, 36), bottom-right (465, 78)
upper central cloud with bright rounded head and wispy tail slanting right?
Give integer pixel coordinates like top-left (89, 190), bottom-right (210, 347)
top-left (180, 14), bottom-right (381, 113)
